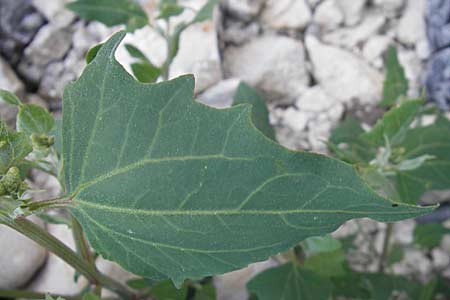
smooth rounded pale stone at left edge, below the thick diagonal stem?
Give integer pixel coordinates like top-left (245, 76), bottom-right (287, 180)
top-left (0, 220), bottom-right (47, 289)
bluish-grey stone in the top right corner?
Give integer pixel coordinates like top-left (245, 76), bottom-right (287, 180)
top-left (426, 0), bottom-right (450, 51)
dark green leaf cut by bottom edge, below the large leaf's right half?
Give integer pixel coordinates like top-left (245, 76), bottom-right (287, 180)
top-left (247, 263), bottom-right (332, 300)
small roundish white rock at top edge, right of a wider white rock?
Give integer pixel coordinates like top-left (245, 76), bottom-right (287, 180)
top-left (314, 0), bottom-right (344, 30)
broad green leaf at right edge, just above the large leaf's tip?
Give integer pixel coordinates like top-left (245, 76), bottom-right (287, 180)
top-left (395, 118), bottom-right (450, 204)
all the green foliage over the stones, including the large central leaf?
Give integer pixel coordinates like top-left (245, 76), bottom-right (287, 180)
top-left (0, 29), bottom-right (449, 300)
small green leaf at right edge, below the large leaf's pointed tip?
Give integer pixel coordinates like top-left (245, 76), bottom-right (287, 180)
top-left (413, 223), bottom-right (450, 249)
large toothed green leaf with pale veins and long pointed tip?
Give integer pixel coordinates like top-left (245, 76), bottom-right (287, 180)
top-left (62, 32), bottom-right (430, 285)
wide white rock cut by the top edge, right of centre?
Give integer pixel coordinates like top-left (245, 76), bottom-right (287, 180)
top-left (261, 0), bottom-right (312, 29)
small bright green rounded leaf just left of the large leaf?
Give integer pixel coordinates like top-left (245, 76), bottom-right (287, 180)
top-left (16, 104), bottom-right (55, 135)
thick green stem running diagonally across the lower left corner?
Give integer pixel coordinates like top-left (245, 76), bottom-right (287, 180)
top-left (0, 211), bottom-right (134, 299)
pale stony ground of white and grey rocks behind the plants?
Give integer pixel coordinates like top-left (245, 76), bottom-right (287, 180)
top-left (0, 0), bottom-right (450, 300)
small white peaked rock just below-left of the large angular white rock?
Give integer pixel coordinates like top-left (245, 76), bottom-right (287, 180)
top-left (296, 85), bottom-right (337, 113)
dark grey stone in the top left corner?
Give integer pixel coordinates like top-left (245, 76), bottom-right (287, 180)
top-left (0, 0), bottom-right (45, 64)
